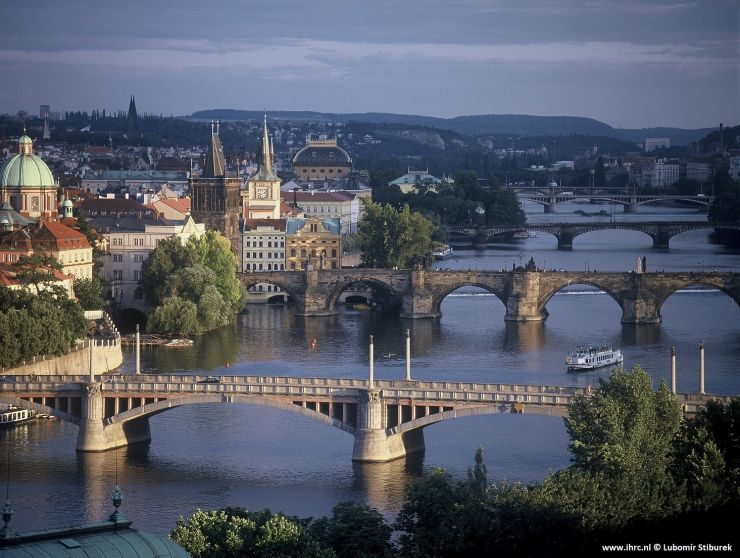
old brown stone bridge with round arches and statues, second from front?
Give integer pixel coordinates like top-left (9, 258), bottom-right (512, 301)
top-left (238, 268), bottom-right (740, 324)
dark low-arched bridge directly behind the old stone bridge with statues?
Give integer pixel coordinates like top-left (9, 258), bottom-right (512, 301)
top-left (447, 221), bottom-right (740, 250)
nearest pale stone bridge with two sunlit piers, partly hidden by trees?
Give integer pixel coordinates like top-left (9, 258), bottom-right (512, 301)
top-left (0, 375), bottom-right (730, 462)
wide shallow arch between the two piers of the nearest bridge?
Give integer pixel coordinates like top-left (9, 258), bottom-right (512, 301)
top-left (105, 394), bottom-right (355, 435)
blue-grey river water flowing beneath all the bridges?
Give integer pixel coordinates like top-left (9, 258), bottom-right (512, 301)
top-left (0, 204), bottom-right (740, 533)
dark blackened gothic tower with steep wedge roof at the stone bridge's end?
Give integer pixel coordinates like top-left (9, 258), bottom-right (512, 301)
top-left (189, 124), bottom-right (241, 256)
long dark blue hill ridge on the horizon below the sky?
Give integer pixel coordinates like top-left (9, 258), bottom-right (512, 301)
top-left (190, 109), bottom-right (714, 145)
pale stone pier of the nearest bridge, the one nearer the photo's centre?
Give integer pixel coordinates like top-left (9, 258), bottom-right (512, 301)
top-left (352, 389), bottom-right (424, 463)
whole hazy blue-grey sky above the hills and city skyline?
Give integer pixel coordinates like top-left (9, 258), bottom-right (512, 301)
top-left (0, 0), bottom-right (740, 128)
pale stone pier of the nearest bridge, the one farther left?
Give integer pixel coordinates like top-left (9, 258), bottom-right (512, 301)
top-left (76, 382), bottom-right (152, 452)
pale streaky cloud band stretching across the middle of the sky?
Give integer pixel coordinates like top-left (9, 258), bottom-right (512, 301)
top-left (0, 39), bottom-right (736, 78)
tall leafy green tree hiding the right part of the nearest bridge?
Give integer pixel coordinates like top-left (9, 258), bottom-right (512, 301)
top-left (565, 366), bottom-right (681, 521)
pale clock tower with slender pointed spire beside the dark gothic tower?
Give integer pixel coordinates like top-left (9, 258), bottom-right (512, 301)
top-left (244, 115), bottom-right (280, 219)
